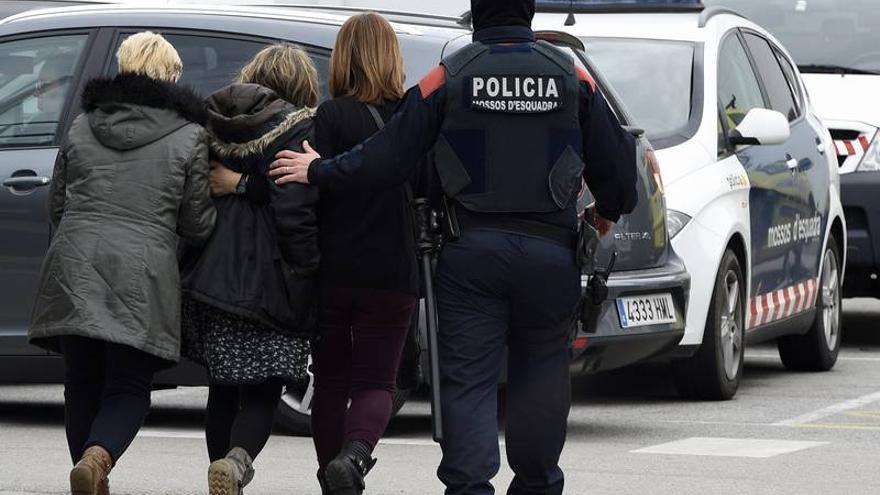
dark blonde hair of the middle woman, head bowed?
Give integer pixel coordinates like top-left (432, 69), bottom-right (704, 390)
top-left (238, 43), bottom-right (321, 107)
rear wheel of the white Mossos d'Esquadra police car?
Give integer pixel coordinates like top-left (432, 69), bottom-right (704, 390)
top-left (777, 237), bottom-right (843, 371)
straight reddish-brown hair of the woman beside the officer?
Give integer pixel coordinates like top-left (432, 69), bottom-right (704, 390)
top-left (330, 13), bottom-right (406, 104)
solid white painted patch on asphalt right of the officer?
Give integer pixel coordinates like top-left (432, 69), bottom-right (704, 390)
top-left (632, 437), bottom-right (828, 459)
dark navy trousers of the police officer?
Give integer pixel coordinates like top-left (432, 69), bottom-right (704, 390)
top-left (436, 230), bottom-right (580, 495)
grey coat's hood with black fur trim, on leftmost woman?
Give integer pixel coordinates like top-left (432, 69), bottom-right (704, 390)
top-left (82, 74), bottom-right (207, 150)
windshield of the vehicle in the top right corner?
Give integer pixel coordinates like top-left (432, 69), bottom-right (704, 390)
top-left (704, 0), bottom-right (880, 74)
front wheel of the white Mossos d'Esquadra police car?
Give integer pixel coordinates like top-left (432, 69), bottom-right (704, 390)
top-left (672, 250), bottom-right (746, 400)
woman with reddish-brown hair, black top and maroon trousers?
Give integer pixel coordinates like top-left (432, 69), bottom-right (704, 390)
top-left (274, 14), bottom-right (418, 495)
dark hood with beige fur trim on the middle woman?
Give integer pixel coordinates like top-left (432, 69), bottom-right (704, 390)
top-left (208, 84), bottom-right (315, 160)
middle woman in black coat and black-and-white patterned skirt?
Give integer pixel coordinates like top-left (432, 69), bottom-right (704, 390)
top-left (183, 45), bottom-right (319, 495)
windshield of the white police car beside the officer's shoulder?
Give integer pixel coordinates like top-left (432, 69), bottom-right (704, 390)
top-left (584, 38), bottom-right (694, 148)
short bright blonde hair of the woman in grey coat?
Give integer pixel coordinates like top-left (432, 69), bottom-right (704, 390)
top-left (116, 31), bottom-right (183, 81)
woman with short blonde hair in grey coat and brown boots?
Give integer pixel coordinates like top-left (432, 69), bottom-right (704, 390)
top-left (30, 33), bottom-right (215, 495)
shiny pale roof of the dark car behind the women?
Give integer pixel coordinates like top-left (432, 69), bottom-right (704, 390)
top-left (0, 0), bottom-right (470, 46)
